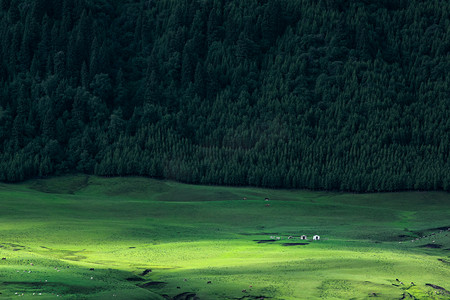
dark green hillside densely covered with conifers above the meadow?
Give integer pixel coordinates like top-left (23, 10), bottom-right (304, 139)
top-left (0, 0), bottom-right (450, 192)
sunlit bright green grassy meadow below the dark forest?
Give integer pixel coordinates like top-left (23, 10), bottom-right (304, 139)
top-left (0, 175), bottom-right (450, 300)
